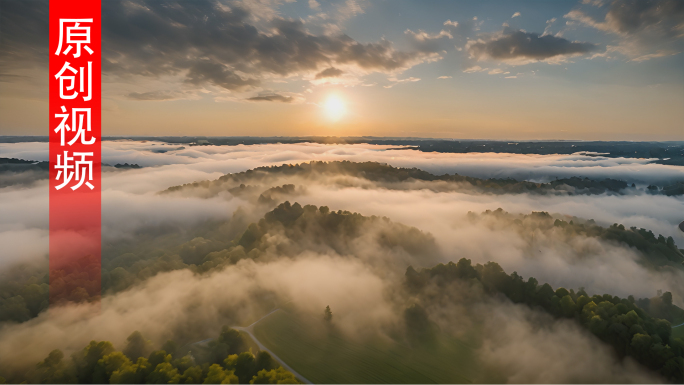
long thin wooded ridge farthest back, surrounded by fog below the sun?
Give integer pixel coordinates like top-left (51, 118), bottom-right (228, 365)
top-left (164, 161), bottom-right (684, 195)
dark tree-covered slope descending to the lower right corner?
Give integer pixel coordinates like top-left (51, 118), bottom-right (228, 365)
top-left (405, 258), bottom-right (684, 383)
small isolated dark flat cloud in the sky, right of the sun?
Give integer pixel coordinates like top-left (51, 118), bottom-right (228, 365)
top-left (467, 28), bottom-right (597, 60)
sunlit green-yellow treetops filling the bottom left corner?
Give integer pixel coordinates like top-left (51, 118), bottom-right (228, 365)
top-left (0, 327), bottom-right (300, 384)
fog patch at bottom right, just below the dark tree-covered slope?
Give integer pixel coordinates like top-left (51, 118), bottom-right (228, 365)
top-left (478, 303), bottom-right (662, 383)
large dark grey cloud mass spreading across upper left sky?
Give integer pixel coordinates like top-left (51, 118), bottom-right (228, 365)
top-left (0, 0), bottom-right (427, 90)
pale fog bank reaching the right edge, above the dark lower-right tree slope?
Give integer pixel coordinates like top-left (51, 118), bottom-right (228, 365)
top-left (297, 185), bottom-right (684, 298)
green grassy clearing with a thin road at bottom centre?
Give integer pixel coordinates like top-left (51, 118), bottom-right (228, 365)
top-left (254, 311), bottom-right (501, 383)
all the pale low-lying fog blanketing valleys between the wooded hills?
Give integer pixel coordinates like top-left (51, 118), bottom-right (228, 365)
top-left (0, 141), bottom-right (684, 382)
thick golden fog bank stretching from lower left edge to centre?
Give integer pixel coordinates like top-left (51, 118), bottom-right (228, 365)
top-left (0, 254), bottom-right (391, 367)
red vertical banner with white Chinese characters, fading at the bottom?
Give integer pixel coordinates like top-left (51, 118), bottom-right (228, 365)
top-left (49, 0), bottom-right (102, 304)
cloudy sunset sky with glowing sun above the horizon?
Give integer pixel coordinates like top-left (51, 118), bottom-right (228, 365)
top-left (0, 0), bottom-right (684, 140)
